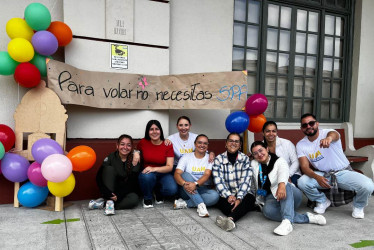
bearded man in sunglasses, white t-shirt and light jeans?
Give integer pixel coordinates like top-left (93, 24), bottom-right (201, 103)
top-left (296, 114), bottom-right (374, 219)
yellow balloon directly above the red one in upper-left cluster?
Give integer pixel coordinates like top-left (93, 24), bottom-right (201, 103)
top-left (8, 38), bottom-right (34, 62)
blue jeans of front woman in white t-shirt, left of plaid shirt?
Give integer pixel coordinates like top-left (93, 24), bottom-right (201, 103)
top-left (179, 172), bottom-right (219, 207)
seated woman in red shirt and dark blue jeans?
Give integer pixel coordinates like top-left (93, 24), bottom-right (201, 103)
top-left (137, 120), bottom-right (177, 208)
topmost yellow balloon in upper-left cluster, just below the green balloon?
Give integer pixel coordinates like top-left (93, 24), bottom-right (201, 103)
top-left (6, 17), bottom-right (34, 42)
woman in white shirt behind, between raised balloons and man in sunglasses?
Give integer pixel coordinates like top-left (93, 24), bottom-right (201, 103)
top-left (262, 121), bottom-right (301, 186)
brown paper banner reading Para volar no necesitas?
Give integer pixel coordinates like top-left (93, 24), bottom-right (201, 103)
top-left (47, 60), bottom-right (247, 110)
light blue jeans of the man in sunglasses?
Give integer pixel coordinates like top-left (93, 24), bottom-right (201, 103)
top-left (298, 170), bottom-right (374, 208)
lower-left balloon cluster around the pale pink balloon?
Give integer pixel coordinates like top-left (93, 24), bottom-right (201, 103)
top-left (0, 124), bottom-right (96, 207)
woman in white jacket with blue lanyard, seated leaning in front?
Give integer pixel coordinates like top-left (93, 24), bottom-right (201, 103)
top-left (251, 141), bottom-right (326, 236)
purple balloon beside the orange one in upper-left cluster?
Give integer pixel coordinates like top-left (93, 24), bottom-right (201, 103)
top-left (31, 30), bottom-right (58, 56)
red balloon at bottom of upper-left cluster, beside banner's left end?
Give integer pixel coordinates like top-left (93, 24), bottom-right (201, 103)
top-left (14, 62), bottom-right (41, 88)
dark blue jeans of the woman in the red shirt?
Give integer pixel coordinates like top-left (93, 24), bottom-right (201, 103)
top-left (139, 172), bottom-right (178, 200)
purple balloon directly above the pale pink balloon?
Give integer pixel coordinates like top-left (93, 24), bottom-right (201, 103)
top-left (31, 138), bottom-right (64, 164)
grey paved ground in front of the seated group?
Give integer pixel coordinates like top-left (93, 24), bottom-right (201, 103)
top-left (0, 197), bottom-right (374, 250)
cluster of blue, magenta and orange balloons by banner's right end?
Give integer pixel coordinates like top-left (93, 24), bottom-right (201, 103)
top-left (225, 94), bottom-right (268, 134)
